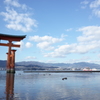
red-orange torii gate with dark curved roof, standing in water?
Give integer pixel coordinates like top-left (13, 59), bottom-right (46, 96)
top-left (0, 33), bottom-right (26, 73)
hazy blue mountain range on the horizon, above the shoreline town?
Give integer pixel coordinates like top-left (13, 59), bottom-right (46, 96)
top-left (0, 60), bottom-right (100, 68)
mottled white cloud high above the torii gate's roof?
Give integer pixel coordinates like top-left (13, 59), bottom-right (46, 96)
top-left (0, 7), bottom-right (37, 32)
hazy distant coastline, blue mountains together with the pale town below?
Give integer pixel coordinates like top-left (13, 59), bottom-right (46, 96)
top-left (0, 60), bottom-right (100, 70)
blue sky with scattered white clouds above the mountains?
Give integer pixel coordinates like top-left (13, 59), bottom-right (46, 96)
top-left (0, 0), bottom-right (100, 64)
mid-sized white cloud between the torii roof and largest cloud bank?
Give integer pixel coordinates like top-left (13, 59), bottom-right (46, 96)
top-left (29, 35), bottom-right (63, 50)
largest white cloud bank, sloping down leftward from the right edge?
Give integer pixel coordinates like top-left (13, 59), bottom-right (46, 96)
top-left (44, 26), bottom-right (100, 57)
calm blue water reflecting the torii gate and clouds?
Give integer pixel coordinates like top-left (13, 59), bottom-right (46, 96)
top-left (0, 71), bottom-right (100, 100)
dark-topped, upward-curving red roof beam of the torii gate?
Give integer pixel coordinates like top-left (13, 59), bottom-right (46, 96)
top-left (0, 33), bottom-right (26, 41)
